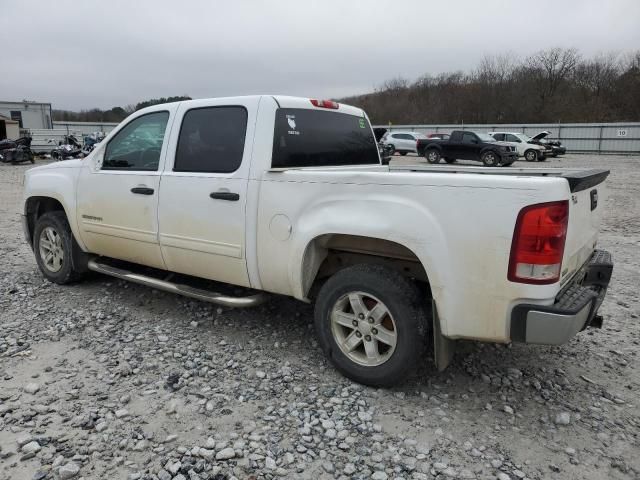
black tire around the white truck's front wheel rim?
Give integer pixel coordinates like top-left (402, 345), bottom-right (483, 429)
top-left (33, 211), bottom-right (82, 285)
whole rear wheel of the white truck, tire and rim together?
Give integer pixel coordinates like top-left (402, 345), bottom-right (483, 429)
top-left (315, 264), bottom-right (428, 387)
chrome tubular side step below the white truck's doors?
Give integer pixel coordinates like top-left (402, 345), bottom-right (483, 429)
top-left (87, 258), bottom-right (267, 307)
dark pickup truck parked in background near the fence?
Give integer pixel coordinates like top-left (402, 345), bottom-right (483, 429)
top-left (416, 130), bottom-right (518, 167)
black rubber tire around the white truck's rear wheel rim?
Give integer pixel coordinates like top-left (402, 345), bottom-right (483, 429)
top-left (315, 264), bottom-right (430, 387)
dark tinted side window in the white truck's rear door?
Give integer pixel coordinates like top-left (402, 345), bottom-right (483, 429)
top-left (173, 106), bottom-right (247, 173)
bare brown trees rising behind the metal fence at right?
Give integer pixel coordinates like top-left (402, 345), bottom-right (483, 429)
top-left (340, 48), bottom-right (640, 125)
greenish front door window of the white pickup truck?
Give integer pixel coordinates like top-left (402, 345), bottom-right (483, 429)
top-left (102, 112), bottom-right (169, 171)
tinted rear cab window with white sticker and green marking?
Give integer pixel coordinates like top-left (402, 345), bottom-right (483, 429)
top-left (271, 108), bottom-right (380, 168)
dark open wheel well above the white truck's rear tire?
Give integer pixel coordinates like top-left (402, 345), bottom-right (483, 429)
top-left (303, 234), bottom-right (429, 296)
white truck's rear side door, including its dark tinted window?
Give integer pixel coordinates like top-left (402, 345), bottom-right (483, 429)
top-left (158, 97), bottom-right (259, 286)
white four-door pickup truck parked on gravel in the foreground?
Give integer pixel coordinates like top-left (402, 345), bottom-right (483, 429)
top-left (23, 95), bottom-right (612, 386)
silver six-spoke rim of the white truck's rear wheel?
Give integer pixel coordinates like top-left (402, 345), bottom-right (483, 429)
top-left (331, 292), bottom-right (398, 367)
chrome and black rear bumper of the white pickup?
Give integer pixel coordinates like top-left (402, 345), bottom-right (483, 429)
top-left (511, 250), bottom-right (613, 345)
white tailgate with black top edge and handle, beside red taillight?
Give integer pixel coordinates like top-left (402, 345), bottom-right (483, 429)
top-left (560, 170), bottom-right (609, 284)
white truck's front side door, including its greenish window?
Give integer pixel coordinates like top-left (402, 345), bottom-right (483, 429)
top-left (77, 105), bottom-right (175, 268)
